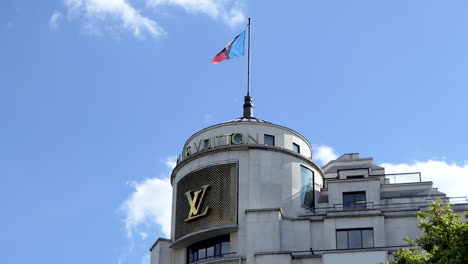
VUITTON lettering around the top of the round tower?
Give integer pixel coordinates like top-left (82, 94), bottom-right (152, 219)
top-left (178, 133), bottom-right (258, 162)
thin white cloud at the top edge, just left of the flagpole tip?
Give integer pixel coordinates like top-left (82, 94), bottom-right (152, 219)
top-left (146, 0), bottom-right (245, 26)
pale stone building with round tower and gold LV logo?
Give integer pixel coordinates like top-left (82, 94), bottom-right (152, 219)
top-left (150, 97), bottom-right (468, 264)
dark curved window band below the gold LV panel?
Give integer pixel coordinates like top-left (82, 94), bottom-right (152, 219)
top-left (187, 235), bottom-right (231, 263)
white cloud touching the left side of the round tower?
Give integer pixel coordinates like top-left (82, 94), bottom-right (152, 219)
top-left (121, 157), bottom-right (176, 239)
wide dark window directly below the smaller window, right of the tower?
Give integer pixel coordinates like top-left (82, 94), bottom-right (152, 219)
top-left (336, 228), bottom-right (374, 249)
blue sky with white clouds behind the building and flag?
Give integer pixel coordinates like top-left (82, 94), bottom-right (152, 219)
top-left (0, 0), bottom-right (468, 264)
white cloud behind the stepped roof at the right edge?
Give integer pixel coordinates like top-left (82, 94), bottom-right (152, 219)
top-left (380, 160), bottom-right (468, 197)
